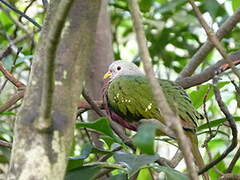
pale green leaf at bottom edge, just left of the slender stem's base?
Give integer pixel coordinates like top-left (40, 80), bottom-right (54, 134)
top-left (154, 165), bottom-right (188, 180)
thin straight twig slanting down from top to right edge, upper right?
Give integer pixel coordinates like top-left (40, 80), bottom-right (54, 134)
top-left (188, 0), bottom-right (240, 80)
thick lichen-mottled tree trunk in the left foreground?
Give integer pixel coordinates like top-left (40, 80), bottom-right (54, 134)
top-left (8, 0), bottom-right (101, 180)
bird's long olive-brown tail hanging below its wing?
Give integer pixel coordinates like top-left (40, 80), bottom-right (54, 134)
top-left (185, 131), bottom-right (209, 180)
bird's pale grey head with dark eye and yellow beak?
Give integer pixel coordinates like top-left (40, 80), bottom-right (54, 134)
top-left (103, 60), bottom-right (144, 81)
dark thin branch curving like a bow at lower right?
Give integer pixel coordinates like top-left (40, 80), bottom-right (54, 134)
top-left (198, 78), bottom-right (238, 174)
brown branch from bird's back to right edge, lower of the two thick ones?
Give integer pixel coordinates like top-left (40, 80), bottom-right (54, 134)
top-left (176, 51), bottom-right (240, 89)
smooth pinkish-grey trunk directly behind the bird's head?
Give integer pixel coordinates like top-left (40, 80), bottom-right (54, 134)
top-left (86, 0), bottom-right (113, 147)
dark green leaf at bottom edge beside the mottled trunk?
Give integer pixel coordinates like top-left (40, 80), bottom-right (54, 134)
top-left (64, 166), bottom-right (101, 180)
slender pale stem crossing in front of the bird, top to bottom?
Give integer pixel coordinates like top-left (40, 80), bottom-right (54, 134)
top-left (128, 0), bottom-right (198, 179)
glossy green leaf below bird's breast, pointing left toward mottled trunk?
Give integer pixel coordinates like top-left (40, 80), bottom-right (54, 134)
top-left (76, 118), bottom-right (122, 144)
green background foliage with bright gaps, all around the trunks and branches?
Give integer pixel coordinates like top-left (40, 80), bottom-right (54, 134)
top-left (0, 0), bottom-right (240, 180)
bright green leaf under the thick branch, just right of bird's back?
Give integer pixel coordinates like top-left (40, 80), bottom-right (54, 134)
top-left (189, 81), bottom-right (229, 108)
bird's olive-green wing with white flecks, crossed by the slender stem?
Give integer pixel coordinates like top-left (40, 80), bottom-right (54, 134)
top-left (108, 76), bottom-right (201, 129)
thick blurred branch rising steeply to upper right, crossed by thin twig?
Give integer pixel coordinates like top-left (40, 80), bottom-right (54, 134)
top-left (177, 8), bottom-right (240, 80)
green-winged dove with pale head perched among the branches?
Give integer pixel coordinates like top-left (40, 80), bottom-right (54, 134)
top-left (103, 60), bottom-right (209, 180)
